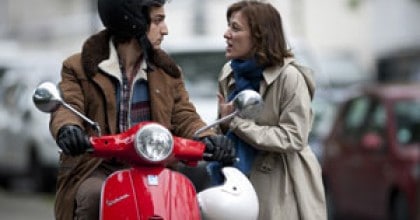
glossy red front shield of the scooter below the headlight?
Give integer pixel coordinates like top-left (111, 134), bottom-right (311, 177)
top-left (100, 167), bottom-right (200, 220)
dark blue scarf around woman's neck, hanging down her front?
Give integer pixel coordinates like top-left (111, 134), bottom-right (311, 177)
top-left (208, 59), bottom-right (264, 185)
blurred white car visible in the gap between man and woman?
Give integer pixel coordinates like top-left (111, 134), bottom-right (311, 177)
top-left (162, 37), bottom-right (226, 123)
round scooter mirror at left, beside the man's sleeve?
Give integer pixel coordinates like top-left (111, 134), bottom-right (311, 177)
top-left (32, 82), bottom-right (63, 113)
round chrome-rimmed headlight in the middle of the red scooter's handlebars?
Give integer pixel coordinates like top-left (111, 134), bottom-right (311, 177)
top-left (134, 124), bottom-right (174, 162)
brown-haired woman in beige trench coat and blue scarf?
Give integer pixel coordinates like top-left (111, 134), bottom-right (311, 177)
top-left (219, 1), bottom-right (327, 220)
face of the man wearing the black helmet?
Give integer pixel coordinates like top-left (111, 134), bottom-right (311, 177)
top-left (147, 6), bottom-right (168, 49)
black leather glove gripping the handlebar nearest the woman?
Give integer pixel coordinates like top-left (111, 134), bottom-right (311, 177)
top-left (201, 135), bottom-right (236, 165)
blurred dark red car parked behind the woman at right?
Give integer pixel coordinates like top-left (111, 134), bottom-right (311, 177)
top-left (322, 84), bottom-right (420, 220)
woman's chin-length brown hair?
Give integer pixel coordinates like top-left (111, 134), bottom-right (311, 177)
top-left (226, 1), bottom-right (293, 66)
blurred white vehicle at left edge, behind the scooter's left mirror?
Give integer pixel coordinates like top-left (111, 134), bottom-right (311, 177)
top-left (0, 54), bottom-right (60, 192)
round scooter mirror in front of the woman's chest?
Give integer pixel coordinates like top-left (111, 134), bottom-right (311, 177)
top-left (233, 90), bottom-right (263, 119)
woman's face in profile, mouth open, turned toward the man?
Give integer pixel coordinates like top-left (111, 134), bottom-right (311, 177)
top-left (223, 11), bottom-right (253, 60)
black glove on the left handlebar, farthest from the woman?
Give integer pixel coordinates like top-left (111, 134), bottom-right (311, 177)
top-left (56, 125), bottom-right (91, 156)
